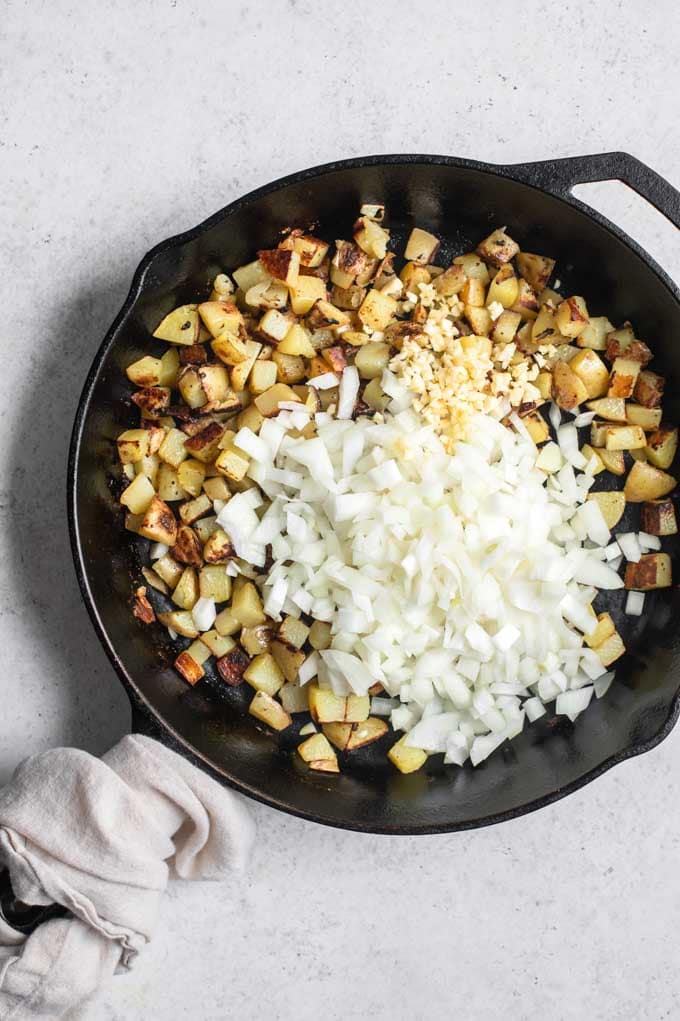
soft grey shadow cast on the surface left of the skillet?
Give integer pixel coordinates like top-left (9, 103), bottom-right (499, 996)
top-left (0, 277), bottom-right (130, 783)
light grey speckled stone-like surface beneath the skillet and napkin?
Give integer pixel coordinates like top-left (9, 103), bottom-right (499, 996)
top-left (0, 0), bottom-right (680, 1021)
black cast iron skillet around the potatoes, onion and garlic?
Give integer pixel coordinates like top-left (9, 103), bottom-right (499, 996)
top-left (68, 153), bottom-right (680, 833)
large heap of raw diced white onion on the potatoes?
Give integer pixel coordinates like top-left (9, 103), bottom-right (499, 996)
top-left (219, 369), bottom-right (616, 765)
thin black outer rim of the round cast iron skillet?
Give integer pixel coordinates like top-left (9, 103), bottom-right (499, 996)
top-left (66, 153), bottom-right (680, 836)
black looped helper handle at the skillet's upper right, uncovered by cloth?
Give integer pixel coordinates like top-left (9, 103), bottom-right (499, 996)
top-left (505, 152), bottom-right (680, 228)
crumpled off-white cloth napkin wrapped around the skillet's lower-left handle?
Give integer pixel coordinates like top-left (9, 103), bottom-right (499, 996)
top-left (0, 735), bottom-right (253, 1021)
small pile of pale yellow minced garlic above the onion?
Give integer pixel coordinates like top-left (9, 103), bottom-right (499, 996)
top-left (390, 283), bottom-right (556, 452)
